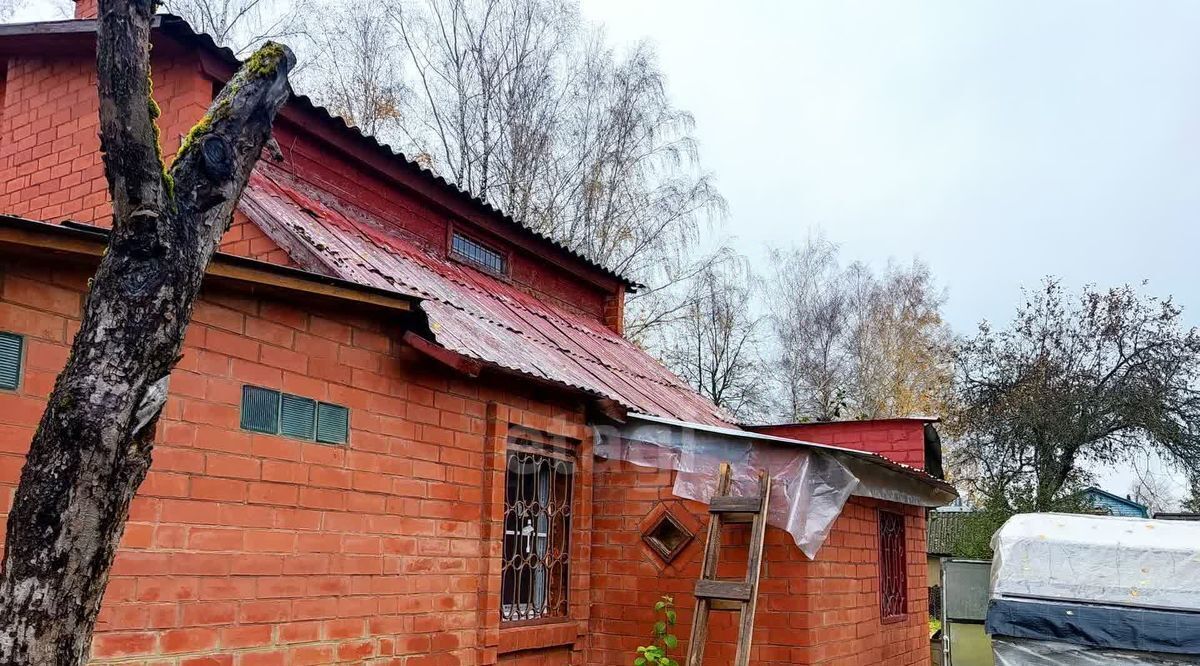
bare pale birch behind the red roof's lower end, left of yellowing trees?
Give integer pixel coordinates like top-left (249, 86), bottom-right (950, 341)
top-left (664, 258), bottom-right (769, 421)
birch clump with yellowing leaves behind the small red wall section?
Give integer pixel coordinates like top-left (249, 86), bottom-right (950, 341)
top-left (767, 236), bottom-right (953, 420)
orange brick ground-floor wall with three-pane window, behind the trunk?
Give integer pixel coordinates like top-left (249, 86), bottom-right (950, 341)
top-left (0, 256), bottom-right (590, 666)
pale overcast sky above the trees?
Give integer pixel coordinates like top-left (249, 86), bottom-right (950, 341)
top-left (583, 0), bottom-right (1200, 332)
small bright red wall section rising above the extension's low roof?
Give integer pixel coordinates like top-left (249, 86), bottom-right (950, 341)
top-left (750, 419), bottom-right (925, 469)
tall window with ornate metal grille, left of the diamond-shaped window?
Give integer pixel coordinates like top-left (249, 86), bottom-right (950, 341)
top-left (500, 439), bottom-right (575, 623)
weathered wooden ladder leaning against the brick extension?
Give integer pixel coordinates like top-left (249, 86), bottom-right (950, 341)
top-left (686, 462), bottom-right (770, 666)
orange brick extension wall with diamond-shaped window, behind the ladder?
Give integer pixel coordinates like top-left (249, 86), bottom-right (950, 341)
top-left (588, 461), bottom-right (929, 666)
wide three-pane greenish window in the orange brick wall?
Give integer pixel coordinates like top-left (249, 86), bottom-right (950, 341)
top-left (241, 386), bottom-right (350, 444)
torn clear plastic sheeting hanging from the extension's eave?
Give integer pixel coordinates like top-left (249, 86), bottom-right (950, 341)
top-left (594, 416), bottom-right (954, 559)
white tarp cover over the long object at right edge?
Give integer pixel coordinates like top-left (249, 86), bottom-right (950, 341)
top-left (991, 514), bottom-right (1200, 611)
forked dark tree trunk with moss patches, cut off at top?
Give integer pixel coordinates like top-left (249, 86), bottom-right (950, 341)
top-left (0, 0), bottom-right (295, 666)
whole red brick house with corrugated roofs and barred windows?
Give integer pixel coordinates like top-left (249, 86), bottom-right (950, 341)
top-left (0, 5), bottom-right (953, 666)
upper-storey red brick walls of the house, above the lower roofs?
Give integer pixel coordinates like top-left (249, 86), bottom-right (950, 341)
top-left (0, 42), bottom-right (624, 330)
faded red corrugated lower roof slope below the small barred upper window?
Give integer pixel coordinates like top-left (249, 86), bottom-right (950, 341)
top-left (240, 166), bottom-right (731, 426)
